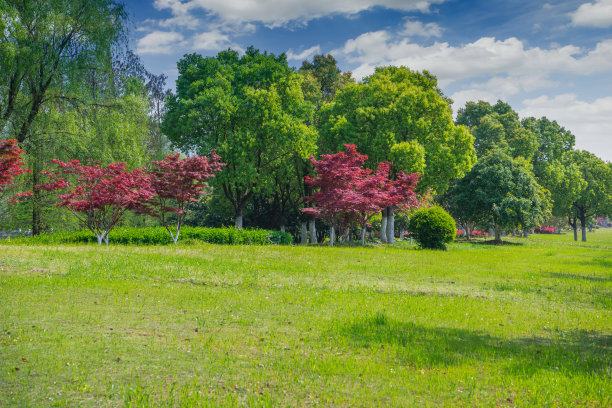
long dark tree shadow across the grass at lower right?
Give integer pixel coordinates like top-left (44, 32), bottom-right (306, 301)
top-left (340, 313), bottom-right (612, 375)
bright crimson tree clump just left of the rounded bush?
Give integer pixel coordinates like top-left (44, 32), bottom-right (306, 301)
top-left (303, 145), bottom-right (419, 246)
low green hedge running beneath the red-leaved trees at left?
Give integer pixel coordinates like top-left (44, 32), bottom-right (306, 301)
top-left (12, 226), bottom-right (293, 245)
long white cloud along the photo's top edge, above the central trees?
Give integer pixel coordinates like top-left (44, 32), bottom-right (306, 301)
top-left (160, 0), bottom-right (445, 27)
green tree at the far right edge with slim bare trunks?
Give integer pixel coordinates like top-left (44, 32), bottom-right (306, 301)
top-left (564, 150), bottom-right (612, 241)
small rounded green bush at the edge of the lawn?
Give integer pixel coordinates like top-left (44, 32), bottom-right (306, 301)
top-left (408, 207), bottom-right (457, 249)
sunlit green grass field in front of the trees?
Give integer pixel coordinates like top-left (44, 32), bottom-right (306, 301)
top-left (0, 230), bottom-right (612, 407)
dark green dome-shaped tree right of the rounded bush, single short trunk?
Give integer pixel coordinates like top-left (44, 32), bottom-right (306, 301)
top-left (448, 151), bottom-right (550, 242)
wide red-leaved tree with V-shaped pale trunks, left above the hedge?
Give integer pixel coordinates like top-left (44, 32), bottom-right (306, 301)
top-left (35, 160), bottom-right (154, 245)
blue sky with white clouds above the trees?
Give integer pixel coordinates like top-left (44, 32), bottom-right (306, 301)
top-left (125, 0), bottom-right (612, 161)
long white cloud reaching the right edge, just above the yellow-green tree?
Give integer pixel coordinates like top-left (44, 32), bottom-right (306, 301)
top-left (332, 31), bottom-right (612, 84)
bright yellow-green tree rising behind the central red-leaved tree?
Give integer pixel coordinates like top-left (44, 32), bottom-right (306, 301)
top-left (319, 67), bottom-right (475, 243)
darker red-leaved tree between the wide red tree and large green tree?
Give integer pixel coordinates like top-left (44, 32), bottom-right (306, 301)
top-left (141, 151), bottom-right (225, 244)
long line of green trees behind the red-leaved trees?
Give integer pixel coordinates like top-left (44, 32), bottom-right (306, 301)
top-left (0, 0), bottom-right (612, 243)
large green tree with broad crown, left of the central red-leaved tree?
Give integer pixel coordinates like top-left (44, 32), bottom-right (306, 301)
top-left (162, 47), bottom-right (317, 228)
